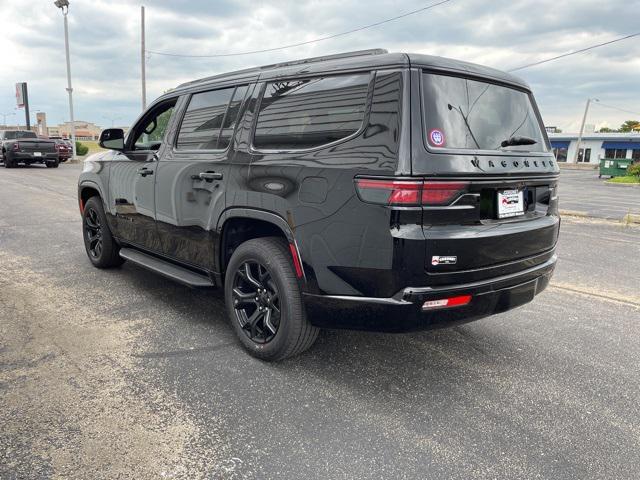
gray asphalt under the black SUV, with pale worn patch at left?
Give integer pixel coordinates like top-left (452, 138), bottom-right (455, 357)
top-left (0, 165), bottom-right (640, 479)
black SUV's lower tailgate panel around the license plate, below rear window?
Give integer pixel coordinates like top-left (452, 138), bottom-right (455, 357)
top-left (422, 176), bottom-right (559, 284)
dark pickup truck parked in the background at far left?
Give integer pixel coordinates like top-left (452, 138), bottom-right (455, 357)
top-left (0, 130), bottom-right (60, 168)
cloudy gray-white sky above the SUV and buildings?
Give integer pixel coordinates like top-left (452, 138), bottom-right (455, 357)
top-left (0, 0), bottom-right (640, 132)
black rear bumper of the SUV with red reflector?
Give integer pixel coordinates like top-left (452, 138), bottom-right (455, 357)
top-left (304, 255), bottom-right (557, 332)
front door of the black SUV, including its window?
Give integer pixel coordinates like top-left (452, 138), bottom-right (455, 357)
top-left (109, 98), bottom-right (176, 252)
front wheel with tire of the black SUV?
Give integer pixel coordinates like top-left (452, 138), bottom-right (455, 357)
top-left (82, 196), bottom-right (124, 268)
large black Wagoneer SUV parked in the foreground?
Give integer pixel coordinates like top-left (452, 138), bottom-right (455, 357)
top-left (78, 50), bottom-right (560, 360)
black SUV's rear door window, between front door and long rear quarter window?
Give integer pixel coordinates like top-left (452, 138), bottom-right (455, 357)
top-left (176, 87), bottom-right (241, 150)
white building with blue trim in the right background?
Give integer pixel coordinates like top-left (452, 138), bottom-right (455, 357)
top-left (549, 133), bottom-right (640, 165)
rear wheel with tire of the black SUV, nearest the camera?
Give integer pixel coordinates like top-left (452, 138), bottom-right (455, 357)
top-left (224, 237), bottom-right (320, 361)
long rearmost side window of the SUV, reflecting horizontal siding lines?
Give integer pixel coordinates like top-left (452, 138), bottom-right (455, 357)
top-left (253, 73), bottom-right (370, 149)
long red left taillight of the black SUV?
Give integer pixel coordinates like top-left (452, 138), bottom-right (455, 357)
top-left (356, 178), bottom-right (468, 206)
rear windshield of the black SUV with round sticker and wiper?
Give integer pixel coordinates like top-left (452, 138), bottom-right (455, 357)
top-left (422, 73), bottom-right (547, 152)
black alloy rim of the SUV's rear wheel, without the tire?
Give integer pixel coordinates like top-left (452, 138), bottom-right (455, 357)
top-left (233, 260), bottom-right (281, 343)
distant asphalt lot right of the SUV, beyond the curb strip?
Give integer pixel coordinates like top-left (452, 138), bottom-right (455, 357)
top-left (560, 169), bottom-right (640, 220)
